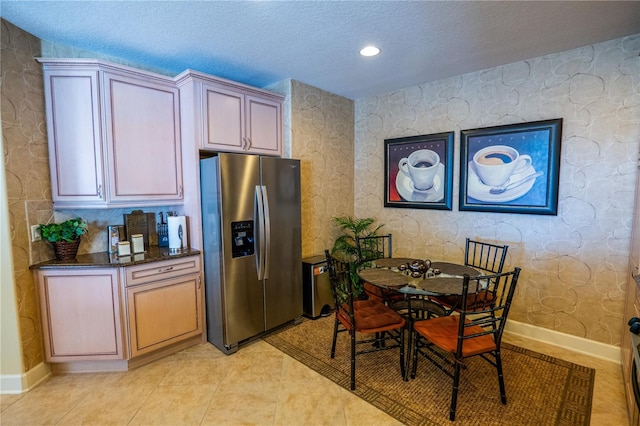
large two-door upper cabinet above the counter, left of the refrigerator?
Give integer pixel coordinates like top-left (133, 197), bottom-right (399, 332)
top-left (39, 58), bottom-right (183, 208)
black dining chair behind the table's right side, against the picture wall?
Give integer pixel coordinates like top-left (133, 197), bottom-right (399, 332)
top-left (429, 238), bottom-right (509, 312)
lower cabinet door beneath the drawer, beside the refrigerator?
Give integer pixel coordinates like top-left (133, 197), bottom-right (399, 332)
top-left (127, 274), bottom-right (202, 358)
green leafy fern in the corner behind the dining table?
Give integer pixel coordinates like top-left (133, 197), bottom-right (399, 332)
top-left (331, 216), bottom-right (384, 296)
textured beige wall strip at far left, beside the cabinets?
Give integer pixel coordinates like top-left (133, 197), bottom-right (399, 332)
top-left (0, 20), bottom-right (46, 371)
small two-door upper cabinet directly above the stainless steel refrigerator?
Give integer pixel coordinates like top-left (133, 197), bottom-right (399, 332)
top-left (176, 70), bottom-right (284, 156)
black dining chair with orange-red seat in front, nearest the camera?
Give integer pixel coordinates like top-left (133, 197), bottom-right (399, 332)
top-left (411, 267), bottom-right (520, 420)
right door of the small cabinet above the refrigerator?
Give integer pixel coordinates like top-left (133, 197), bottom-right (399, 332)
top-left (246, 96), bottom-right (282, 156)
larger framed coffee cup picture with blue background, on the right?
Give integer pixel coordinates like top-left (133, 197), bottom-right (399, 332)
top-left (459, 118), bottom-right (562, 215)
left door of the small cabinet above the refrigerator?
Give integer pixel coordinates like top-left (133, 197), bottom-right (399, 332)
top-left (202, 83), bottom-right (245, 152)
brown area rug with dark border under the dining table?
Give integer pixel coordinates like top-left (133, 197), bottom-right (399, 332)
top-left (264, 316), bottom-right (595, 426)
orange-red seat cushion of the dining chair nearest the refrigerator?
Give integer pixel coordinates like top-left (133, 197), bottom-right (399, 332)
top-left (338, 299), bottom-right (405, 333)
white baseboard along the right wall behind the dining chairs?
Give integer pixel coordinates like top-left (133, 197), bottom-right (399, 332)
top-left (504, 320), bottom-right (621, 364)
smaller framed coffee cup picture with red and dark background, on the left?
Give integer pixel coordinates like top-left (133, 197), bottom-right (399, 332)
top-left (384, 132), bottom-right (453, 210)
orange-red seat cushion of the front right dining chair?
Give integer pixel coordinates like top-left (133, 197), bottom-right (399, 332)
top-left (413, 315), bottom-right (496, 358)
